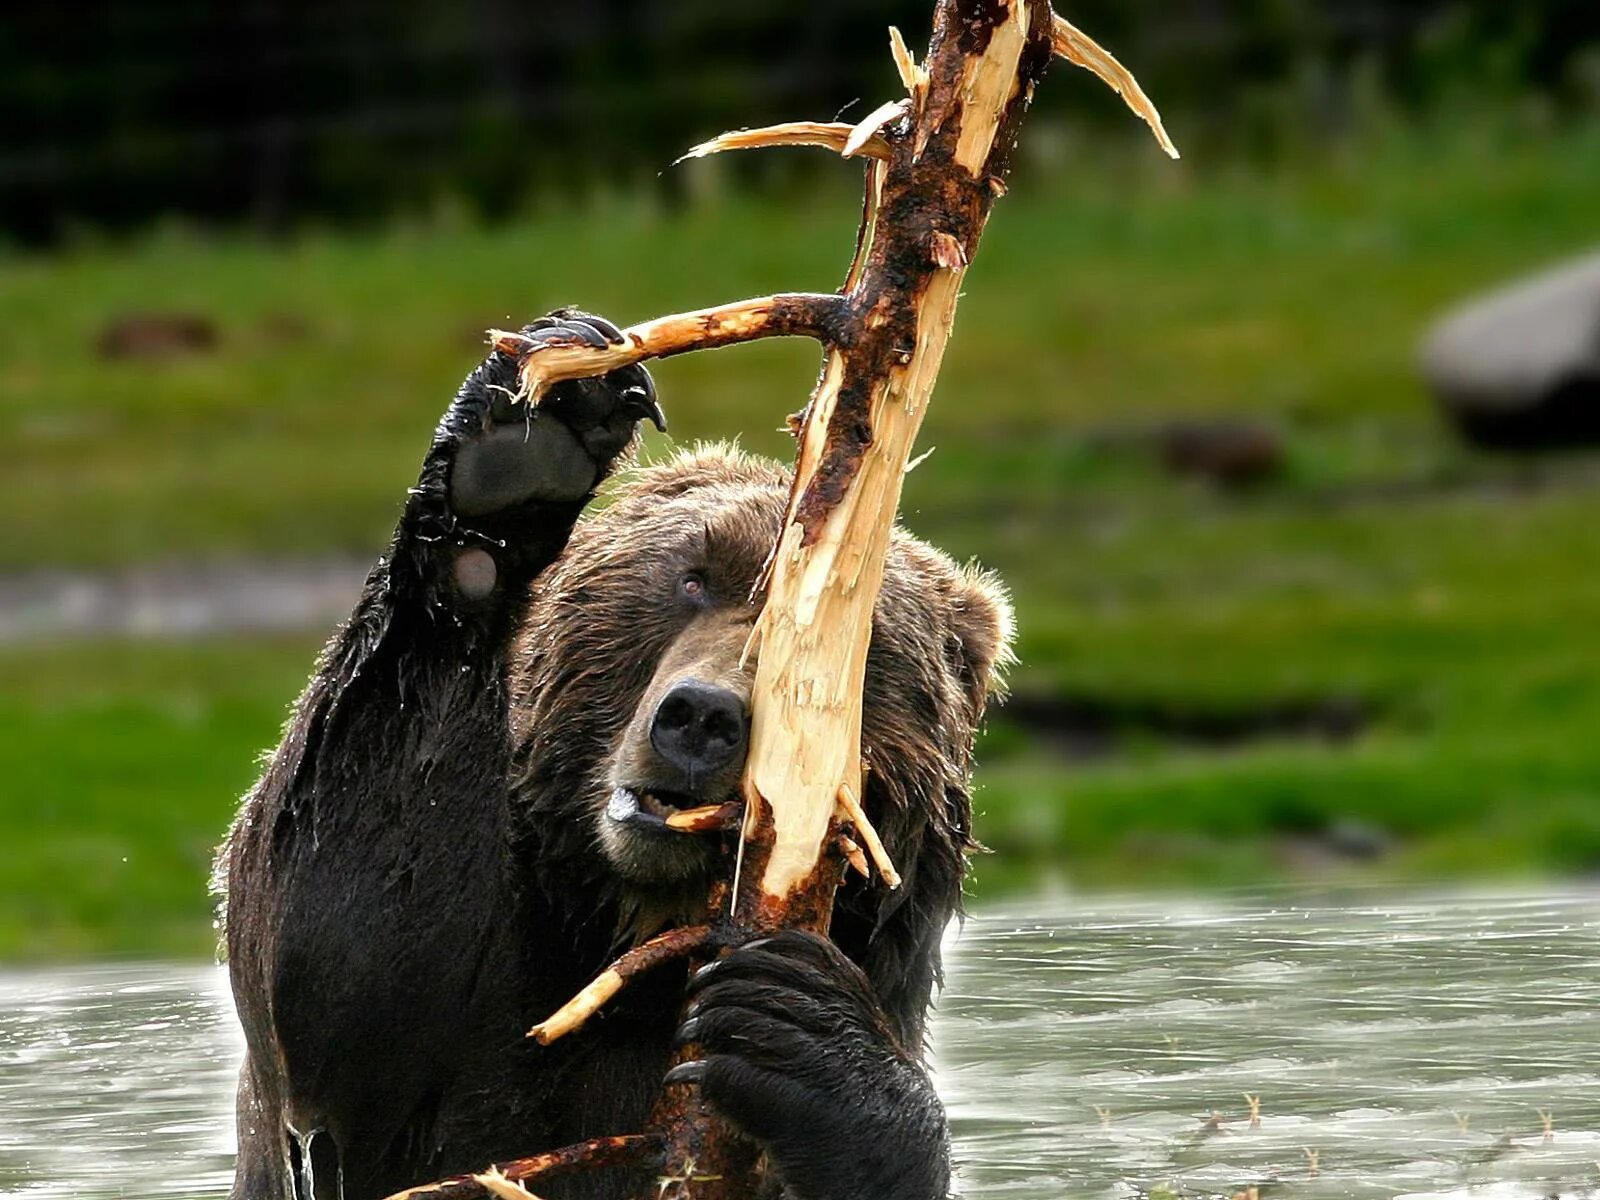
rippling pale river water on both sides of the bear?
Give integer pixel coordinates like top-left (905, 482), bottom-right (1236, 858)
top-left (0, 893), bottom-right (1600, 1200)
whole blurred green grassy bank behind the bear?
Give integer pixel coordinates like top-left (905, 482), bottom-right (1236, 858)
top-left (0, 128), bottom-right (1600, 958)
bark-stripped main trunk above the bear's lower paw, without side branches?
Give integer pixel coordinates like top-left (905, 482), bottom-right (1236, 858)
top-left (739, 0), bottom-right (1051, 909)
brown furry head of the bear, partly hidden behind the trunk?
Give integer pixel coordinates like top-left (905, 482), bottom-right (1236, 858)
top-left (510, 446), bottom-right (1011, 899)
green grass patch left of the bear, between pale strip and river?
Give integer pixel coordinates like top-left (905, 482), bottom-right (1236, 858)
top-left (0, 638), bottom-right (317, 960)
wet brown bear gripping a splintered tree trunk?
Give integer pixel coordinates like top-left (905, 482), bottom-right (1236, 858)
top-left (219, 310), bottom-right (1010, 1200)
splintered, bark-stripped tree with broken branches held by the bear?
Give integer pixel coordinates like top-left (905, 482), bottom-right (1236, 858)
top-left (380, 0), bottom-right (1178, 1200)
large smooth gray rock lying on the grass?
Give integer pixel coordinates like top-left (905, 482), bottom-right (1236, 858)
top-left (1422, 254), bottom-right (1600, 450)
